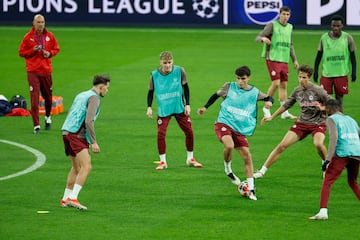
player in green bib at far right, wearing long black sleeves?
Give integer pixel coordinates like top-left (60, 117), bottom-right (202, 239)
top-left (314, 15), bottom-right (356, 111)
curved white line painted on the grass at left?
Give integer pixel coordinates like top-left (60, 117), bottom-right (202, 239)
top-left (0, 139), bottom-right (46, 181)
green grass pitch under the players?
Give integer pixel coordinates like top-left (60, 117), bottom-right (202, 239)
top-left (0, 26), bottom-right (360, 240)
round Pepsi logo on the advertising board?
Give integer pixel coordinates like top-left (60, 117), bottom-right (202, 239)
top-left (244, 0), bottom-right (283, 25)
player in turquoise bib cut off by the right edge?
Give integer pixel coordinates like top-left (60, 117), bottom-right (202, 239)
top-left (309, 99), bottom-right (360, 220)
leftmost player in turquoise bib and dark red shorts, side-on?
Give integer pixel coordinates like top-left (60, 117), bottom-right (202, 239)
top-left (60, 75), bottom-right (110, 210)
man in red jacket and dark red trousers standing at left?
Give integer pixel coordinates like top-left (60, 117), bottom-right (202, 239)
top-left (19, 14), bottom-right (60, 134)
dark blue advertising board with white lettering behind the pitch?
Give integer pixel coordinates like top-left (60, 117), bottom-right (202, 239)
top-left (0, 0), bottom-right (360, 27)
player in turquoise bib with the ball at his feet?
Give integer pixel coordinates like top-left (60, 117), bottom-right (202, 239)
top-left (197, 66), bottom-right (274, 200)
